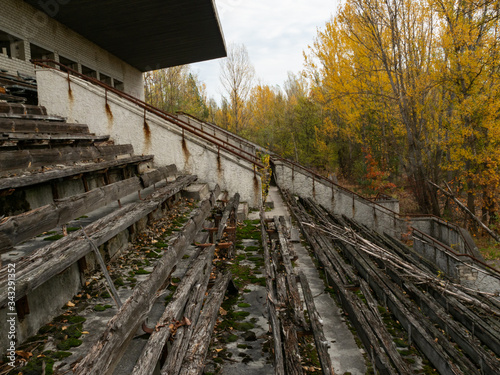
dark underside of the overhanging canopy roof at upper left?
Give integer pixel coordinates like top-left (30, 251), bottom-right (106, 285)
top-left (24, 0), bottom-right (226, 72)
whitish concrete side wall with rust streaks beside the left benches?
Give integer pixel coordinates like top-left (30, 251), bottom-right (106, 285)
top-left (36, 69), bottom-right (262, 208)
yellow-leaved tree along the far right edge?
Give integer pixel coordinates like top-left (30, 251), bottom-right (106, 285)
top-left (429, 0), bottom-right (500, 225)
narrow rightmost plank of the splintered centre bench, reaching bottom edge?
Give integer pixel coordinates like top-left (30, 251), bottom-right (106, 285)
top-left (299, 271), bottom-right (335, 375)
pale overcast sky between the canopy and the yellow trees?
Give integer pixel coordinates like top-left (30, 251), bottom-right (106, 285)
top-left (191, 0), bottom-right (338, 103)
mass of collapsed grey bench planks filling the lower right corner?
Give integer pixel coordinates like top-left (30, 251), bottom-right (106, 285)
top-left (283, 191), bottom-right (500, 374)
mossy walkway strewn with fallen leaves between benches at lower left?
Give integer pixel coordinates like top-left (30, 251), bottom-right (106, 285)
top-left (0, 199), bottom-right (196, 375)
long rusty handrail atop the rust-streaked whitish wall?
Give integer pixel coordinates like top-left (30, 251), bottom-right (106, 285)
top-left (31, 59), bottom-right (264, 168)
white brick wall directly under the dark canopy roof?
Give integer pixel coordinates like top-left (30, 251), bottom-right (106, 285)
top-left (0, 0), bottom-right (144, 99)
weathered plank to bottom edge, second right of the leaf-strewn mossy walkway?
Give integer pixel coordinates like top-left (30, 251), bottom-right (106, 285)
top-left (132, 245), bottom-right (215, 375)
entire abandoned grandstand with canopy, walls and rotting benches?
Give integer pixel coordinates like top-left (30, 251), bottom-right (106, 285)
top-left (0, 0), bottom-right (500, 375)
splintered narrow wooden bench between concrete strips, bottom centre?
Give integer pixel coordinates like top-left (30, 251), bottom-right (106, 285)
top-left (261, 211), bottom-right (334, 375)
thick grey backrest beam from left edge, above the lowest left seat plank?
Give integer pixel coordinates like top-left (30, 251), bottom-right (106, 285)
top-left (0, 177), bottom-right (141, 246)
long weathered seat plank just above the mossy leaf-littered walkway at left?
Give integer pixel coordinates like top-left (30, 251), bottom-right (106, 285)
top-left (0, 176), bottom-right (199, 307)
